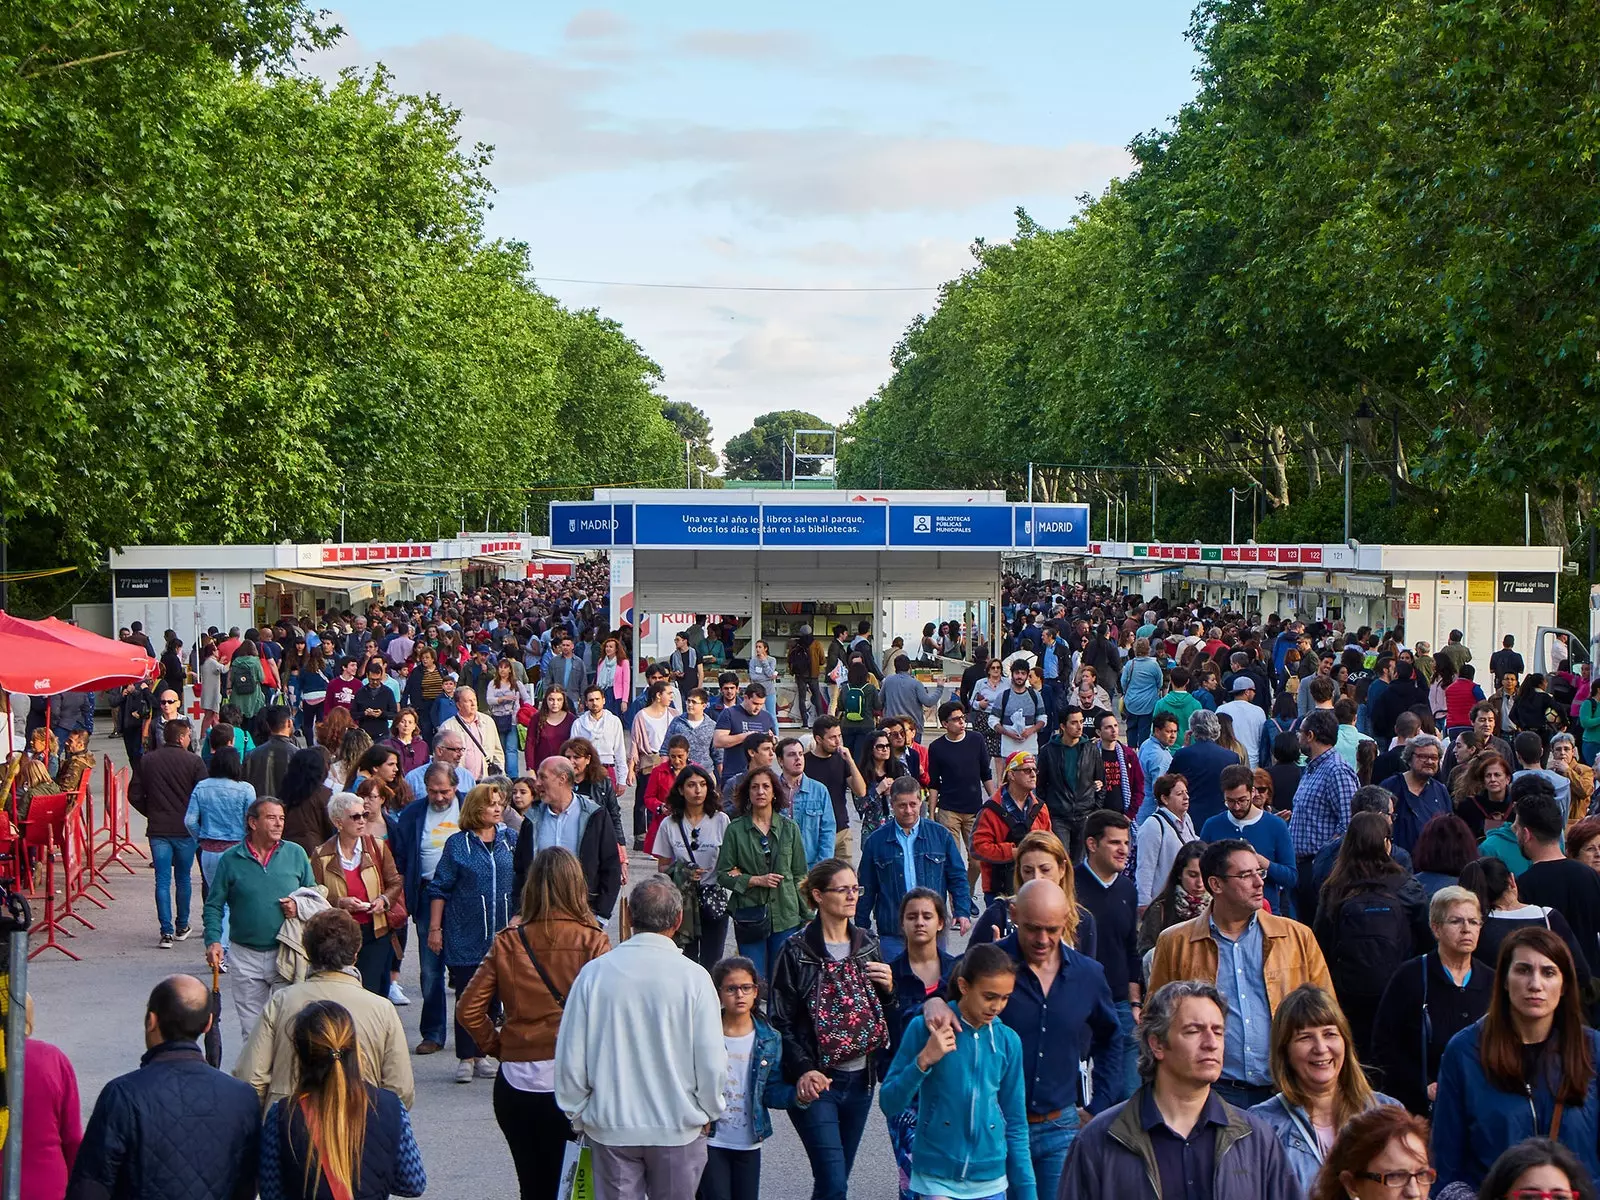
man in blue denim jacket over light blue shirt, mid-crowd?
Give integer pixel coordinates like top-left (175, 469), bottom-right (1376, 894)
top-left (856, 774), bottom-right (971, 962)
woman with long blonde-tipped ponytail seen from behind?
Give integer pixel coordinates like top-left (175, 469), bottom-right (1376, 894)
top-left (258, 1000), bottom-right (427, 1200)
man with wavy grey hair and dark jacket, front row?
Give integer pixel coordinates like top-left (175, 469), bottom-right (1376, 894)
top-left (1059, 979), bottom-right (1301, 1200)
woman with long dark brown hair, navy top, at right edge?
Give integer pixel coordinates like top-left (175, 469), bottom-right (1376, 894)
top-left (1434, 926), bottom-right (1600, 1187)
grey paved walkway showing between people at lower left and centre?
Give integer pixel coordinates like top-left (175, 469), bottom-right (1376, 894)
top-left (29, 734), bottom-right (896, 1200)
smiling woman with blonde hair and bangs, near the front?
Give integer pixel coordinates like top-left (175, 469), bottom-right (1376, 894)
top-left (1251, 984), bottom-right (1400, 1189)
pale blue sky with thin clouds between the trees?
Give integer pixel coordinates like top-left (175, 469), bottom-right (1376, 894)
top-left (307, 0), bottom-right (1195, 445)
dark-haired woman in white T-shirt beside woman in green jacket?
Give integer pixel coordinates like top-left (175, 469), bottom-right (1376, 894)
top-left (650, 763), bottom-right (728, 971)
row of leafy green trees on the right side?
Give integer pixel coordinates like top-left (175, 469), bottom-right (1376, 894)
top-left (840, 0), bottom-right (1600, 546)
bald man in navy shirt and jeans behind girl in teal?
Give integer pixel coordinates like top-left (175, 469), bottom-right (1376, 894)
top-left (922, 878), bottom-right (1120, 1197)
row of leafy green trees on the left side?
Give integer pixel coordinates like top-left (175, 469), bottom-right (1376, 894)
top-left (0, 0), bottom-right (683, 563)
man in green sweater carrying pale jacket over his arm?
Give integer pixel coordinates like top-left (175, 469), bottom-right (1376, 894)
top-left (205, 797), bottom-right (315, 1042)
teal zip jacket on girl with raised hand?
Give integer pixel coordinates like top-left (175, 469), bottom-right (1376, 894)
top-left (878, 1014), bottom-right (1035, 1195)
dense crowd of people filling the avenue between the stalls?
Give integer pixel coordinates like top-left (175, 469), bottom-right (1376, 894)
top-left (18, 568), bottom-right (1600, 1200)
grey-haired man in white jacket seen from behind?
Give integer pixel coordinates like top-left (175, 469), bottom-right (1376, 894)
top-left (553, 876), bottom-right (728, 1200)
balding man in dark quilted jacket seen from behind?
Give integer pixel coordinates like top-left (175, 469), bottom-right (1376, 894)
top-left (67, 974), bottom-right (261, 1200)
